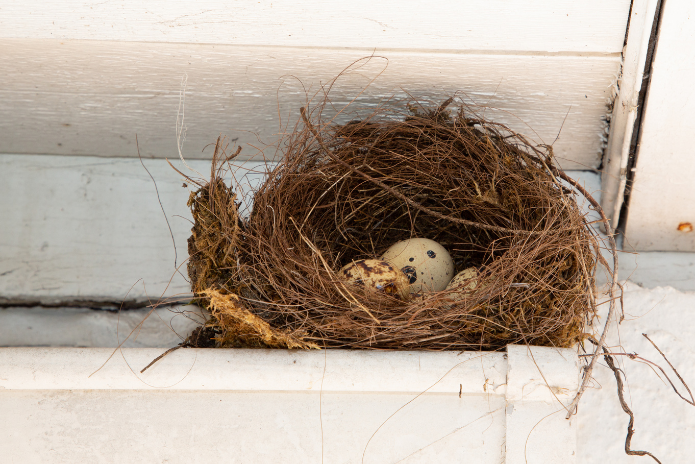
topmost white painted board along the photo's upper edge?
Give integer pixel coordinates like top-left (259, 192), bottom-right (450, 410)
top-left (0, 0), bottom-right (631, 53)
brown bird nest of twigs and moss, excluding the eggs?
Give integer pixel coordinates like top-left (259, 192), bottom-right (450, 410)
top-left (188, 99), bottom-right (599, 350)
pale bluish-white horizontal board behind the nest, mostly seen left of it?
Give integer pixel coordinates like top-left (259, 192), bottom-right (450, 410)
top-left (0, 155), bottom-right (600, 304)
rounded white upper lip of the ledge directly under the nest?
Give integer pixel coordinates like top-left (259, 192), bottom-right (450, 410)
top-left (0, 346), bottom-right (578, 401)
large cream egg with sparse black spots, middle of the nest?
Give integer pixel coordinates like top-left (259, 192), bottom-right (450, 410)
top-left (382, 238), bottom-right (454, 293)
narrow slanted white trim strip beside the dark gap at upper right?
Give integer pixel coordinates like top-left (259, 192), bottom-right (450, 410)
top-left (602, 0), bottom-right (657, 228)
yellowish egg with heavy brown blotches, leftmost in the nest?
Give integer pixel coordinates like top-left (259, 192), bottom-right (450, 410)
top-left (338, 259), bottom-right (409, 299)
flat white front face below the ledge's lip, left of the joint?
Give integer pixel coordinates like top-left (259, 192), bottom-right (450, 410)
top-left (0, 390), bottom-right (506, 464)
